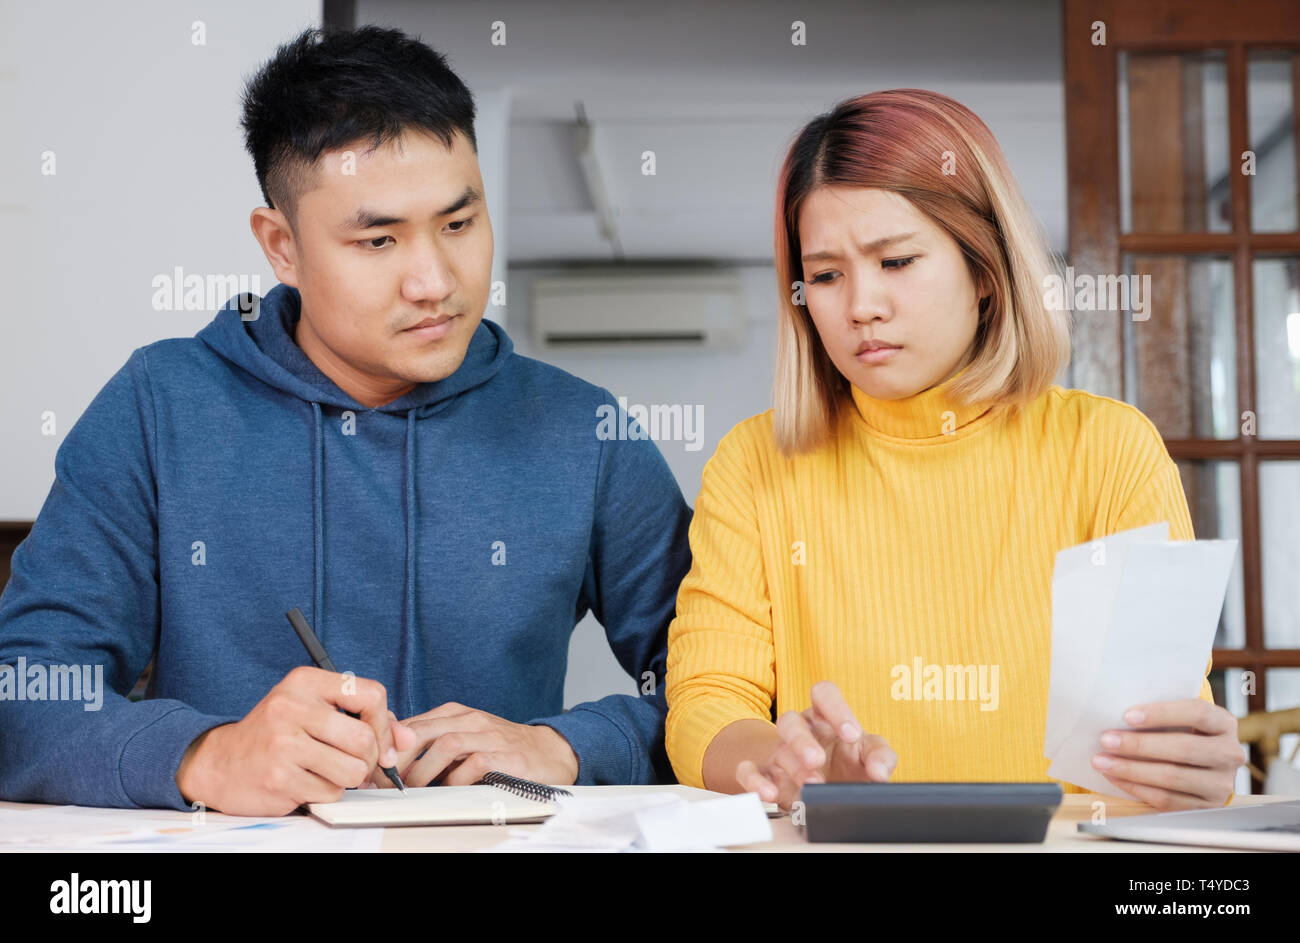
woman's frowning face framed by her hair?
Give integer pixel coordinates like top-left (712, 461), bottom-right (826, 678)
top-left (800, 186), bottom-right (979, 399)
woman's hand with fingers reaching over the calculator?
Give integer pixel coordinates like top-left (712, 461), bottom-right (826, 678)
top-left (736, 682), bottom-right (898, 810)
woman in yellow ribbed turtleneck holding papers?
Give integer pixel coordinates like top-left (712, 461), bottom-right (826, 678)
top-left (667, 90), bottom-right (1243, 809)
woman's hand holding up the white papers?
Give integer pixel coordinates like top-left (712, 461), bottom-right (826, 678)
top-left (1092, 698), bottom-right (1245, 812)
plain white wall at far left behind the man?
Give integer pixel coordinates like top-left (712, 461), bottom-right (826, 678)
top-left (0, 0), bottom-right (321, 520)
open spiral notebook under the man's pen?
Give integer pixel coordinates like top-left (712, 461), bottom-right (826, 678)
top-left (307, 773), bottom-right (573, 829)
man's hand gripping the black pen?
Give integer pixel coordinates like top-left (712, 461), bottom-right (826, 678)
top-left (176, 667), bottom-right (413, 816)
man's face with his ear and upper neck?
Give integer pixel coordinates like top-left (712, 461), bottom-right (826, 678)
top-left (255, 133), bottom-right (493, 406)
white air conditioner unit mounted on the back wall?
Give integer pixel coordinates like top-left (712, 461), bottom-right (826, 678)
top-left (533, 269), bottom-right (745, 350)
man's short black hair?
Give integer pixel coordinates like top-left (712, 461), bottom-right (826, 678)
top-left (241, 26), bottom-right (478, 232)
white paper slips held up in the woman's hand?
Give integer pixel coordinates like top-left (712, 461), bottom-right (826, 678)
top-left (1043, 523), bottom-right (1238, 799)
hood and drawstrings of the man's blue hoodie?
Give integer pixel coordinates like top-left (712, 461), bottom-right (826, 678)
top-left (196, 285), bottom-right (514, 691)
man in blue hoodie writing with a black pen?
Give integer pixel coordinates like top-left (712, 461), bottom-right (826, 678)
top-left (0, 27), bottom-right (690, 814)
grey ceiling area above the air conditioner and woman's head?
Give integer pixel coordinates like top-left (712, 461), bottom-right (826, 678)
top-left (356, 0), bottom-right (1066, 265)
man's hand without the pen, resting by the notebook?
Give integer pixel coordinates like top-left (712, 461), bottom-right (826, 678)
top-left (371, 701), bottom-right (579, 788)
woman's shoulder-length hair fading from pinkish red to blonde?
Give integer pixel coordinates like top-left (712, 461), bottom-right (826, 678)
top-left (772, 88), bottom-right (1070, 454)
